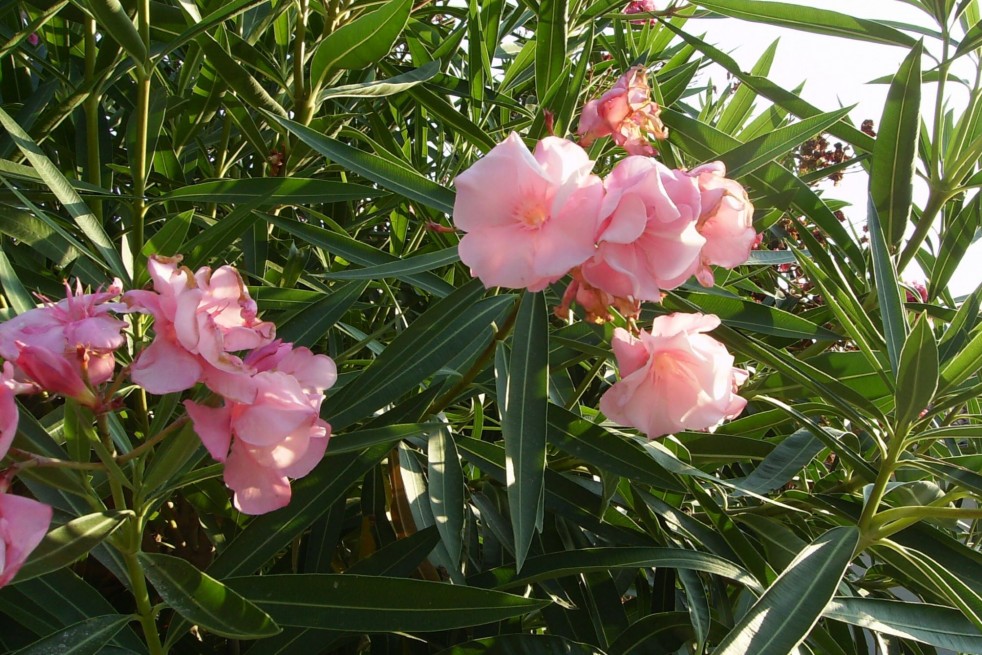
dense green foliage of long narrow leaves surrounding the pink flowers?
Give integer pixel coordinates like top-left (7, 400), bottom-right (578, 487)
top-left (0, 0), bottom-right (982, 655)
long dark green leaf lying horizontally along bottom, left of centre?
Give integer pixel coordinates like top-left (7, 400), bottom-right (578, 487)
top-left (229, 573), bottom-right (549, 632)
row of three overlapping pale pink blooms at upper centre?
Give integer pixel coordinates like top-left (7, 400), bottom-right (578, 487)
top-left (453, 143), bottom-right (757, 316)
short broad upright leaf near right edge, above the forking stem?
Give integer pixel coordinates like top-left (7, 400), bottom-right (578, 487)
top-left (896, 314), bottom-right (938, 426)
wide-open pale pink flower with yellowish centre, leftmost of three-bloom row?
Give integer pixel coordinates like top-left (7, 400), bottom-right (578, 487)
top-left (453, 133), bottom-right (603, 291)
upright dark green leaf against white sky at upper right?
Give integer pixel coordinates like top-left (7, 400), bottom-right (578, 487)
top-left (869, 43), bottom-right (923, 249)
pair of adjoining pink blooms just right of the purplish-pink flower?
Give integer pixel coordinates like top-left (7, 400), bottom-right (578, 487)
top-left (123, 256), bottom-right (337, 514)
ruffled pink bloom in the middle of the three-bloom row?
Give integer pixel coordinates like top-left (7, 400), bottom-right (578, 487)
top-left (581, 157), bottom-right (706, 301)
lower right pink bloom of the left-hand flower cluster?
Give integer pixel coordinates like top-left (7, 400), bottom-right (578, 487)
top-left (184, 342), bottom-right (337, 514)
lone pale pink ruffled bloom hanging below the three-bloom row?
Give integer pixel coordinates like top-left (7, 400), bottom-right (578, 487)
top-left (600, 314), bottom-right (747, 439)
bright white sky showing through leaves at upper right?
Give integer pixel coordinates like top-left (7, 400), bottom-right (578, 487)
top-left (689, 0), bottom-right (982, 298)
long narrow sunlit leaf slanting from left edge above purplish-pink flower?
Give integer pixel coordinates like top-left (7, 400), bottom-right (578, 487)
top-left (0, 109), bottom-right (130, 280)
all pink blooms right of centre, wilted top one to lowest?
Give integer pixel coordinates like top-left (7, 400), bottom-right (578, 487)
top-left (453, 68), bottom-right (758, 439)
